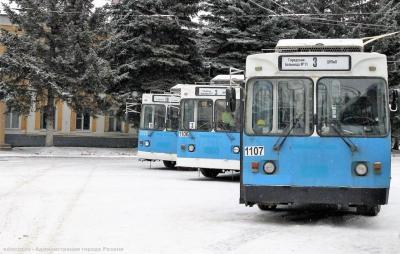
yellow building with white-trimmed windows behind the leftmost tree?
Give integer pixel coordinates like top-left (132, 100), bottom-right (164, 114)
top-left (0, 14), bottom-right (137, 147)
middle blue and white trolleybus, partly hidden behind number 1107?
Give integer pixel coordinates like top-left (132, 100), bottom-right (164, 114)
top-left (177, 75), bottom-right (244, 177)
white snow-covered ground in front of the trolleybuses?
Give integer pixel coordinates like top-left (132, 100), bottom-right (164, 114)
top-left (0, 157), bottom-right (400, 254)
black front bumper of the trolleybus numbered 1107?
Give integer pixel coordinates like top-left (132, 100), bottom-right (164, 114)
top-left (240, 185), bottom-right (389, 205)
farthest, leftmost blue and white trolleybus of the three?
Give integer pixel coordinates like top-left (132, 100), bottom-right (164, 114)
top-left (137, 93), bottom-right (180, 168)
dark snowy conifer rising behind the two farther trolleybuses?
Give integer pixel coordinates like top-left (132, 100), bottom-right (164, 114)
top-left (102, 0), bottom-right (203, 95)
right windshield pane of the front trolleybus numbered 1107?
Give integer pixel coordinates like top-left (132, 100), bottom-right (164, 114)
top-left (317, 78), bottom-right (388, 136)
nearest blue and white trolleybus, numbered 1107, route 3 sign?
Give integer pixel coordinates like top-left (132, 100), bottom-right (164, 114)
top-left (240, 39), bottom-right (391, 215)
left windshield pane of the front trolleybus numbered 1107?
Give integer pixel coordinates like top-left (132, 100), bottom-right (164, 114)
top-left (246, 78), bottom-right (313, 136)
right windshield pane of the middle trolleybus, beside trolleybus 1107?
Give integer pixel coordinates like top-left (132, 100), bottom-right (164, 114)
top-left (215, 100), bottom-right (240, 132)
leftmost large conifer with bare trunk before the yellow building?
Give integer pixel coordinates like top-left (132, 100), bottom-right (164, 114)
top-left (0, 0), bottom-right (113, 146)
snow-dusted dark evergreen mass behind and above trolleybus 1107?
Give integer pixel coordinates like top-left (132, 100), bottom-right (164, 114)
top-left (201, 0), bottom-right (400, 85)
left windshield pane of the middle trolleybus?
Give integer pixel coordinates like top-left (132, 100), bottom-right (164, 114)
top-left (182, 99), bottom-right (213, 131)
